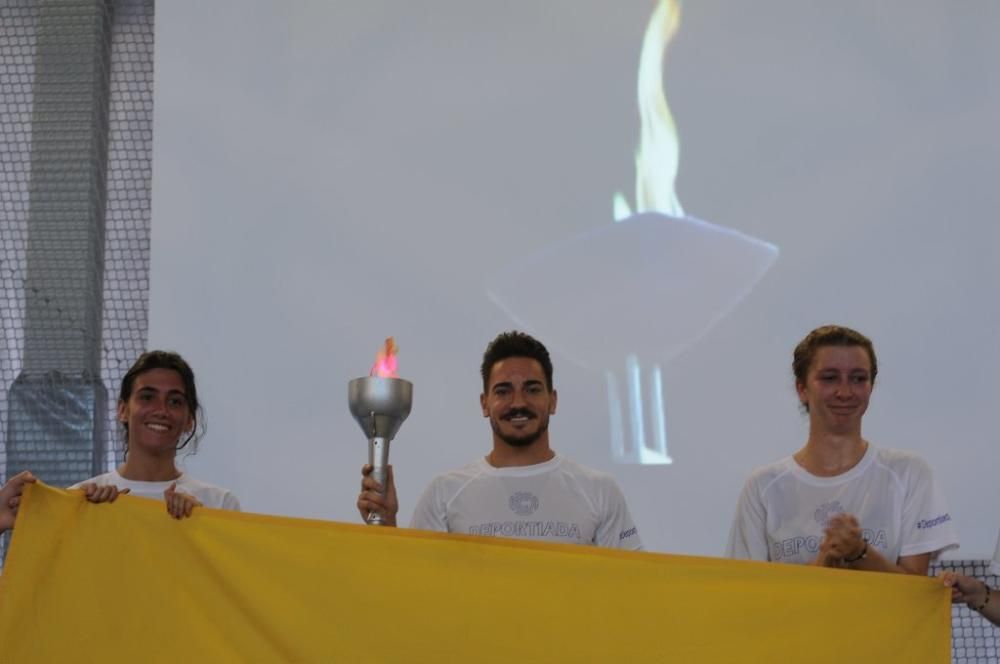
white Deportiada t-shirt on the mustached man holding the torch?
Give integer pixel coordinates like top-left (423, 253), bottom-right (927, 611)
top-left (410, 456), bottom-right (642, 550)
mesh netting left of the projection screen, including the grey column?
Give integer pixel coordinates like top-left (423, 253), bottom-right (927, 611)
top-left (0, 0), bottom-right (154, 556)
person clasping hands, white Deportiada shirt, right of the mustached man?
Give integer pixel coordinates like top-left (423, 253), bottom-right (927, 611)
top-left (726, 325), bottom-right (958, 575)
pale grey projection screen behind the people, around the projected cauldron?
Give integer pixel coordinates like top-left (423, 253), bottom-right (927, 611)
top-left (150, 0), bottom-right (1000, 557)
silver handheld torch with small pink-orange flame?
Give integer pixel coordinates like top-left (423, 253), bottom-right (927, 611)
top-left (347, 337), bottom-right (413, 526)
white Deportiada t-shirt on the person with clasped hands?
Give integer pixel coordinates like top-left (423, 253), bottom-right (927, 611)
top-left (726, 445), bottom-right (958, 564)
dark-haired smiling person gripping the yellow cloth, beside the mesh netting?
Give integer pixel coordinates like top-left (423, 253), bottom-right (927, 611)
top-left (70, 350), bottom-right (240, 519)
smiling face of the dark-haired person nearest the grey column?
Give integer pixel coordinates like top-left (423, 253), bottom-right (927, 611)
top-left (118, 369), bottom-right (194, 456)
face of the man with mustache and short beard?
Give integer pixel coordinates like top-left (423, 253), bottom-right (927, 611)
top-left (479, 357), bottom-right (557, 447)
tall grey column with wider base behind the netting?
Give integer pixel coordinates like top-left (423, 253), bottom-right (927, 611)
top-left (7, 0), bottom-right (112, 486)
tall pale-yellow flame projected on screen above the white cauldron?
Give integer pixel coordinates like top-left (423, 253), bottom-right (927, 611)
top-left (614, 0), bottom-right (684, 221)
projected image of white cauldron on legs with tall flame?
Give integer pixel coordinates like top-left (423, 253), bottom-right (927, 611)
top-left (487, 0), bottom-right (778, 465)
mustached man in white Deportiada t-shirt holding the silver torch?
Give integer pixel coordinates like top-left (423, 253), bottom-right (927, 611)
top-left (357, 332), bottom-right (642, 550)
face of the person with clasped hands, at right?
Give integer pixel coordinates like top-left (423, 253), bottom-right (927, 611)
top-left (795, 346), bottom-right (873, 435)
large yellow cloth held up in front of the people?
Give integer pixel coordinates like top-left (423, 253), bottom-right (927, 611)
top-left (0, 485), bottom-right (951, 664)
